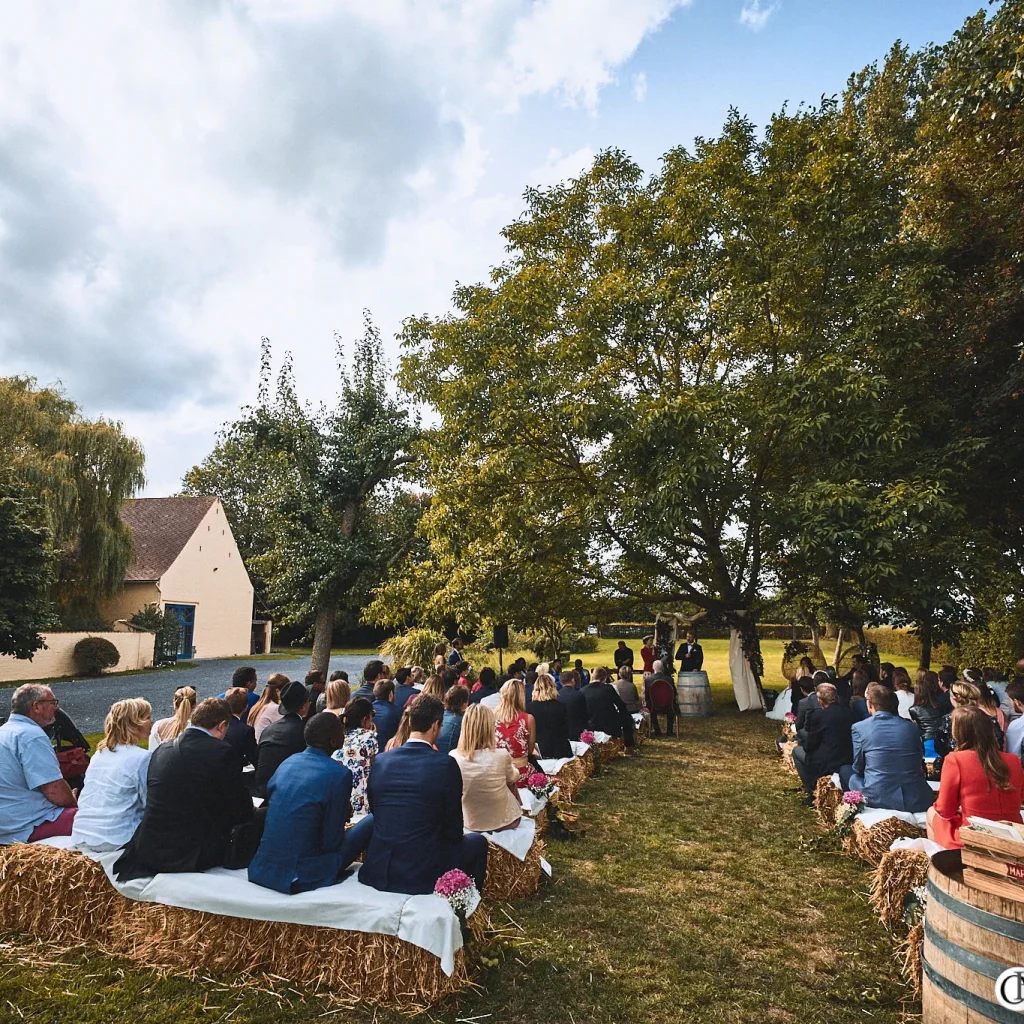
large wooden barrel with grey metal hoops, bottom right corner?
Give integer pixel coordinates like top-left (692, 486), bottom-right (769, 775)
top-left (921, 855), bottom-right (1024, 1024)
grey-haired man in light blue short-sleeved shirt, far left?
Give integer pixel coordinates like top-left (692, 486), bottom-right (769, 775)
top-left (0, 683), bottom-right (78, 844)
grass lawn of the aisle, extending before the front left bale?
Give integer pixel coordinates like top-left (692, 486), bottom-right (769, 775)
top-left (0, 694), bottom-right (906, 1024)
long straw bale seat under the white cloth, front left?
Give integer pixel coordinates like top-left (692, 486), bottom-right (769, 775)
top-left (0, 843), bottom-right (477, 1012)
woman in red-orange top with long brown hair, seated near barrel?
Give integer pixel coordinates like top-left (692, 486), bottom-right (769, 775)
top-left (928, 707), bottom-right (1024, 850)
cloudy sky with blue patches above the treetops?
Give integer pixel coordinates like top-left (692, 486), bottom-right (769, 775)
top-left (0, 0), bottom-right (981, 495)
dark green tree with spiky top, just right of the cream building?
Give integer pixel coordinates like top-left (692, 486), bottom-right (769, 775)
top-left (186, 314), bottom-right (421, 671)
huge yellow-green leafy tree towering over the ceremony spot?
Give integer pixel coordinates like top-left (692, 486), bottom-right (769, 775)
top-left (385, 97), bottom-right (921, 696)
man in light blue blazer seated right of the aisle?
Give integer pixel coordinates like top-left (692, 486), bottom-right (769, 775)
top-left (840, 683), bottom-right (935, 813)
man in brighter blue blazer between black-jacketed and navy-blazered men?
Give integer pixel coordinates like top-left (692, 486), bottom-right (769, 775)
top-left (249, 712), bottom-right (373, 894)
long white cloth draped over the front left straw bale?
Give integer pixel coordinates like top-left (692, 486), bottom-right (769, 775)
top-left (42, 821), bottom-right (468, 977)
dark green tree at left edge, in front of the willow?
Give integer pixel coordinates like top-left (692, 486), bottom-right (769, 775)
top-left (0, 483), bottom-right (54, 658)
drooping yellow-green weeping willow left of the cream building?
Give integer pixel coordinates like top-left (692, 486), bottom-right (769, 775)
top-left (0, 377), bottom-right (145, 625)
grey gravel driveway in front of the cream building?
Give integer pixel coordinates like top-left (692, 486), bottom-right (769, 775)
top-left (0, 654), bottom-right (380, 732)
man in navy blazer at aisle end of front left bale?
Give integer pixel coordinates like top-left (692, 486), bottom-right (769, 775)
top-left (359, 694), bottom-right (487, 896)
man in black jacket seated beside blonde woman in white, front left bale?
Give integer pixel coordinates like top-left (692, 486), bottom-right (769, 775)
top-left (114, 700), bottom-right (252, 882)
